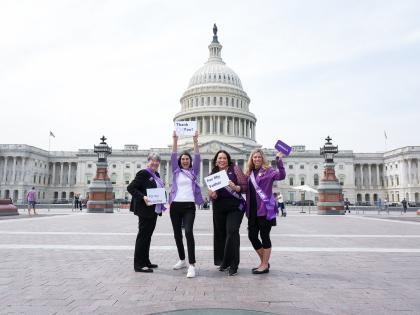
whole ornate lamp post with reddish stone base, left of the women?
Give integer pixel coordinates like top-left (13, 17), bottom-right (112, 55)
top-left (87, 137), bottom-right (114, 213)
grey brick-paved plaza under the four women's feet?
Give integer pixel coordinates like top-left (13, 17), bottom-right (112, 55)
top-left (0, 209), bottom-right (420, 315)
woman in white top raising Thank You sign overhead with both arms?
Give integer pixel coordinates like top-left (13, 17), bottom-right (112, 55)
top-left (169, 131), bottom-right (203, 278)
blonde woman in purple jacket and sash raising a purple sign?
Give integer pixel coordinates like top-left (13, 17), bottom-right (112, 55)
top-left (245, 149), bottom-right (286, 274)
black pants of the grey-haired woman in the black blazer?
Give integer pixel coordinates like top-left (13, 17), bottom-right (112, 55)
top-left (134, 215), bottom-right (157, 268)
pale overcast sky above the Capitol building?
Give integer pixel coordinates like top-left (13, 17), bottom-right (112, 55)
top-left (0, 0), bottom-right (420, 152)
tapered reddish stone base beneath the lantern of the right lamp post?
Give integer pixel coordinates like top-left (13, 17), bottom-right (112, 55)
top-left (318, 163), bottom-right (344, 214)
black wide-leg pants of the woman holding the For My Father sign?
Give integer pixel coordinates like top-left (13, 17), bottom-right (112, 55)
top-left (213, 197), bottom-right (244, 268)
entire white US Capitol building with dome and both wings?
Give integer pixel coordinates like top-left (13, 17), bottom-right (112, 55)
top-left (0, 26), bottom-right (420, 203)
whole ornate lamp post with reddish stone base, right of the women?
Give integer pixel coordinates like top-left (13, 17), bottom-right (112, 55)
top-left (318, 136), bottom-right (344, 214)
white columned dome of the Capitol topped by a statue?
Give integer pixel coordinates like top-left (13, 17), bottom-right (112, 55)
top-left (174, 25), bottom-right (258, 149)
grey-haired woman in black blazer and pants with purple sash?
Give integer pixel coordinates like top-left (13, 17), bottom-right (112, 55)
top-left (127, 152), bottom-right (166, 272)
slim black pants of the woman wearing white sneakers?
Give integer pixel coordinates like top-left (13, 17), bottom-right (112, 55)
top-left (171, 201), bottom-right (195, 264)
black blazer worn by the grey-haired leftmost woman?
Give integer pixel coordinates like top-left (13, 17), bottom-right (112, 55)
top-left (127, 170), bottom-right (160, 218)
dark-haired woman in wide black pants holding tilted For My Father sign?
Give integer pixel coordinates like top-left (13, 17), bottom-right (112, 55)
top-left (209, 150), bottom-right (247, 276)
